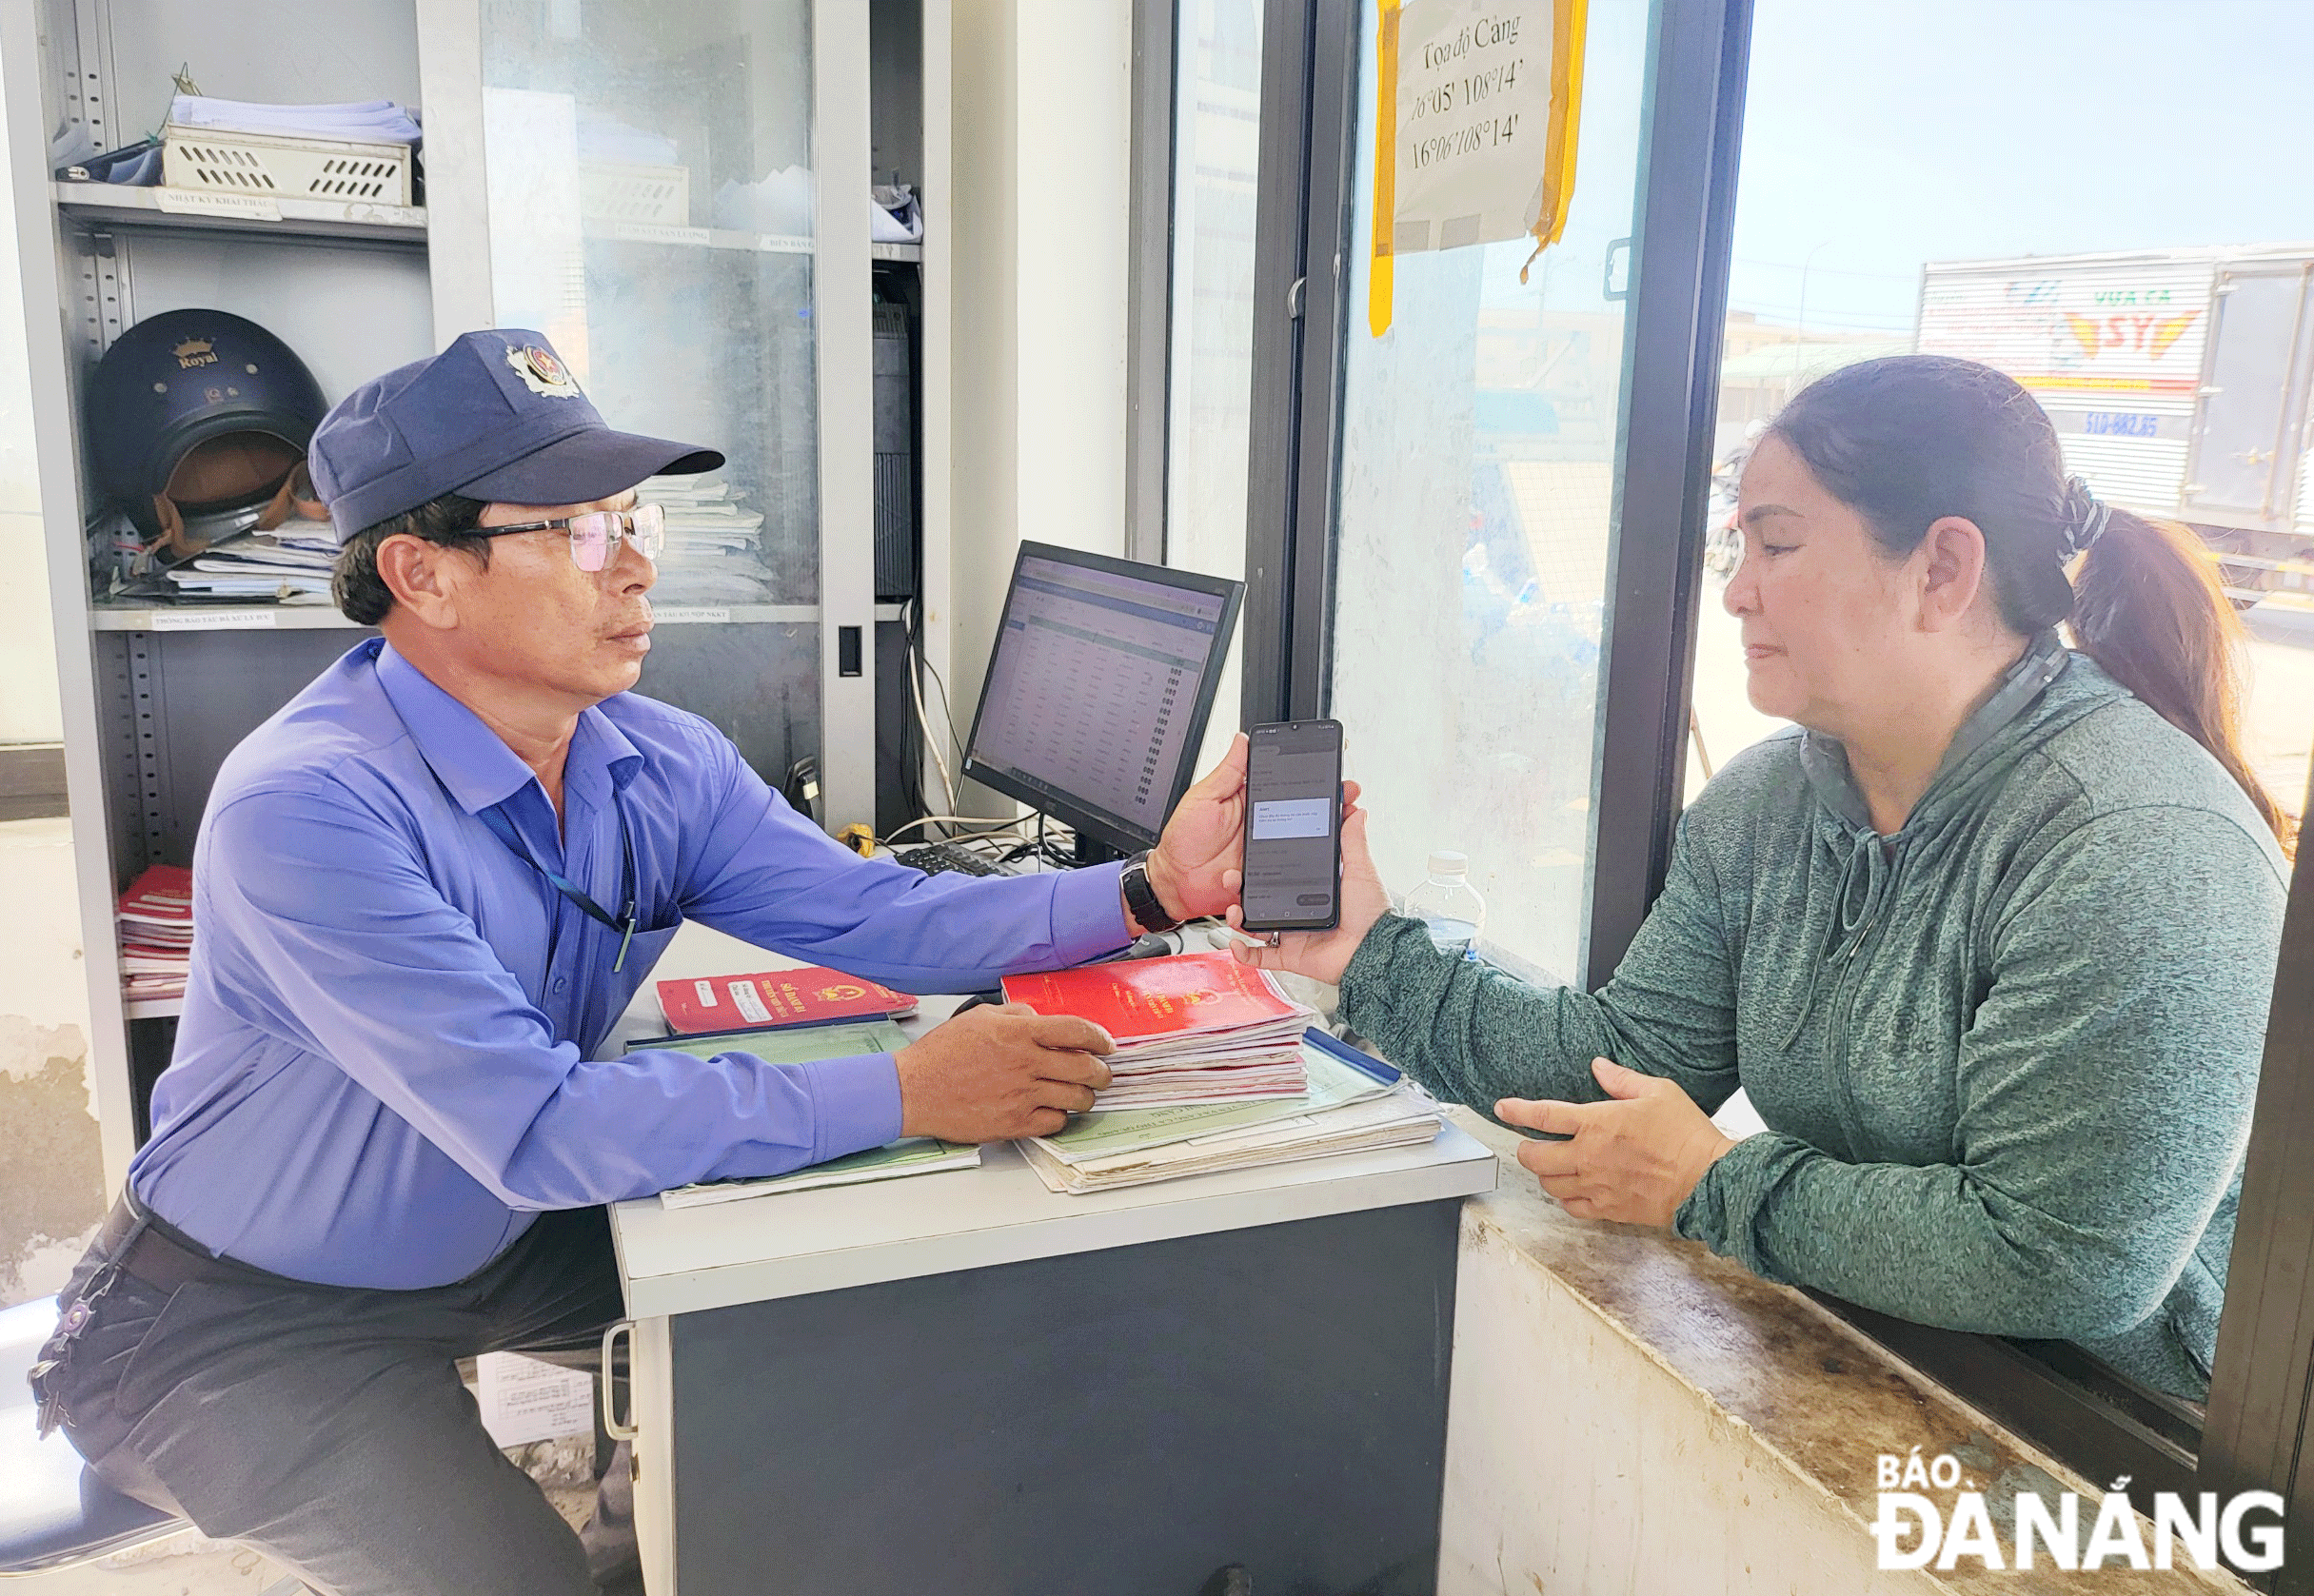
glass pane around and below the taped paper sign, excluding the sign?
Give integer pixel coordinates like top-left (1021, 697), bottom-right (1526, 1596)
top-left (1331, 0), bottom-right (1648, 981)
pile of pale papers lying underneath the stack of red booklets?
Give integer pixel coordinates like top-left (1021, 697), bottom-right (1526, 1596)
top-left (1016, 1032), bottom-right (1442, 1196)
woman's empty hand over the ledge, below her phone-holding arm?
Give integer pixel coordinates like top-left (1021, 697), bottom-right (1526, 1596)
top-left (1494, 1059), bottom-right (1735, 1226)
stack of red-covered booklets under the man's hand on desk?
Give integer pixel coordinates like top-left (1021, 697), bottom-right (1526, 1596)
top-left (1004, 953), bottom-right (1316, 1113)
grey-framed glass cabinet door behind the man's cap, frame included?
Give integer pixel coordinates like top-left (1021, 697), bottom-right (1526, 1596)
top-left (421, 0), bottom-right (875, 826)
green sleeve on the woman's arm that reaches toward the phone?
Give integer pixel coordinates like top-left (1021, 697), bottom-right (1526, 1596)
top-left (1342, 823), bottom-right (1735, 1113)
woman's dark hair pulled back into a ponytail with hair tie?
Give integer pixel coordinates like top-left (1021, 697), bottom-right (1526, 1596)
top-left (1768, 354), bottom-right (2298, 851)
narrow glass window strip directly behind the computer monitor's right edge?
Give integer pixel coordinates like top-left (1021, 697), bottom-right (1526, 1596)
top-left (1166, 0), bottom-right (1263, 770)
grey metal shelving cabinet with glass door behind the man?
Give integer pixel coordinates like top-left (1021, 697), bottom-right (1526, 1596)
top-left (0, 0), bottom-right (951, 1184)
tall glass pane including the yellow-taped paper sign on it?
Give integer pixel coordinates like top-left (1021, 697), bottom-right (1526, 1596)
top-left (1331, 0), bottom-right (1650, 981)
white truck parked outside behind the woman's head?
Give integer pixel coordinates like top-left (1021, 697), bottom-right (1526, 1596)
top-left (1916, 246), bottom-right (2314, 603)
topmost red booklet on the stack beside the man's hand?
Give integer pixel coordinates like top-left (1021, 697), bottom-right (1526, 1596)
top-left (1004, 953), bottom-right (1312, 1053)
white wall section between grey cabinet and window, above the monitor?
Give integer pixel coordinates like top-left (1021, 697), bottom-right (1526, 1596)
top-left (935, 0), bottom-right (1132, 810)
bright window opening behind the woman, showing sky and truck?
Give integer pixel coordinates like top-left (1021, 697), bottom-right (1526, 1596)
top-left (1687, 0), bottom-right (2314, 815)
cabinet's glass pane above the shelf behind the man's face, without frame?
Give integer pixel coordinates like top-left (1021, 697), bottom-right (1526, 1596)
top-left (482, 0), bottom-right (820, 608)
